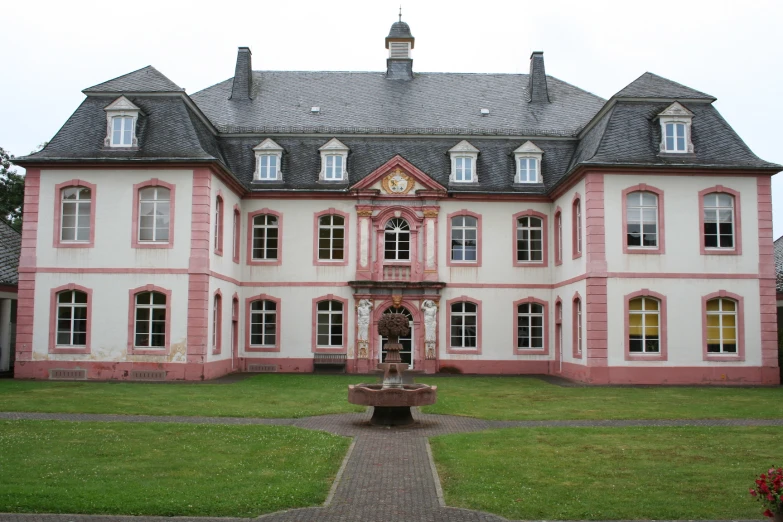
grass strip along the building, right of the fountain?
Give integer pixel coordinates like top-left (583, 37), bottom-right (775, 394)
top-left (422, 376), bottom-right (783, 420)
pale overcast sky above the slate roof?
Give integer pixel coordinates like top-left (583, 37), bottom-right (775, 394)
top-left (0, 0), bottom-right (783, 237)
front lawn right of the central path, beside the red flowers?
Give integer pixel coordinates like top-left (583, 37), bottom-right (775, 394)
top-left (431, 427), bottom-right (783, 520)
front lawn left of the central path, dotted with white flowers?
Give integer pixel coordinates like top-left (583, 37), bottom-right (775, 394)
top-left (0, 421), bottom-right (350, 517)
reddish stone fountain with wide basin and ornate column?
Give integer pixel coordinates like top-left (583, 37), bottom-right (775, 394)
top-left (348, 313), bottom-right (438, 426)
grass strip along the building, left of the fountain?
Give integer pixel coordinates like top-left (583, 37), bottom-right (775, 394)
top-left (0, 374), bottom-right (364, 418)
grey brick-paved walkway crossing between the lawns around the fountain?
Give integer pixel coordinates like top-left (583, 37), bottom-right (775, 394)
top-left (0, 410), bottom-right (783, 522)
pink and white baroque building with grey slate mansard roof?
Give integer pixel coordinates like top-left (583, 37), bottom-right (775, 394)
top-left (15, 22), bottom-right (781, 384)
